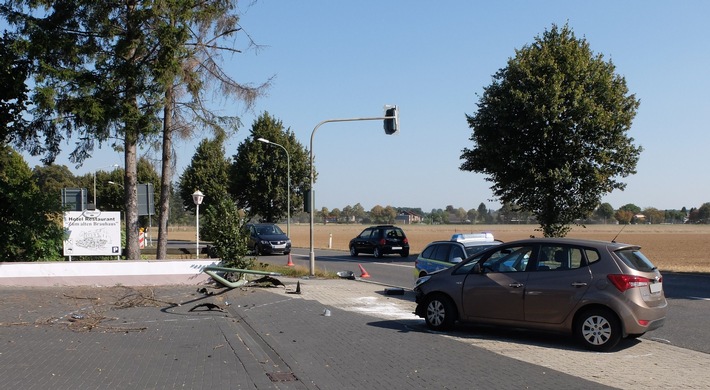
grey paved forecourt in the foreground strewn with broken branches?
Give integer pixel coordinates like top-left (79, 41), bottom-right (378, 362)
top-left (0, 278), bottom-right (710, 389)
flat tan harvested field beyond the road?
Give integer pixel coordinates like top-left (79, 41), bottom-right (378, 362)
top-left (170, 224), bottom-right (710, 273)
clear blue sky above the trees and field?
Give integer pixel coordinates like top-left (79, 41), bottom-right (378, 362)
top-left (22, 0), bottom-right (710, 212)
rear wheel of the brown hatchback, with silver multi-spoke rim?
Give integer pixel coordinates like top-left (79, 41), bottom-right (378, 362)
top-left (574, 309), bottom-right (621, 352)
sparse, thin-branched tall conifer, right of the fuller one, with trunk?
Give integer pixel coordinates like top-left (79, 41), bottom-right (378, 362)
top-left (153, 0), bottom-right (270, 258)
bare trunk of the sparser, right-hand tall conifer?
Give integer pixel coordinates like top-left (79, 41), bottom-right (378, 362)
top-left (156, 86), bottom-right (173, 259)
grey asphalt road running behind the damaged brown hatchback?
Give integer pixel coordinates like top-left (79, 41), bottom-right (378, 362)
top-left (266, 248), bottom-right (710, 354)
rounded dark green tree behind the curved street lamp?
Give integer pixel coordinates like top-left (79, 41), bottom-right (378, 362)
top-left (230, 112), bottom-right (310, 222)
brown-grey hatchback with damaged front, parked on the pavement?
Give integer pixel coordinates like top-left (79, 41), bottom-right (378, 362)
top-left (414, 238), bottom-right (668, 351)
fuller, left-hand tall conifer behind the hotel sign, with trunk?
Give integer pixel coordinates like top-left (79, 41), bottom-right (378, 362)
top-left (0, 0), bottom-right (163, 259)
